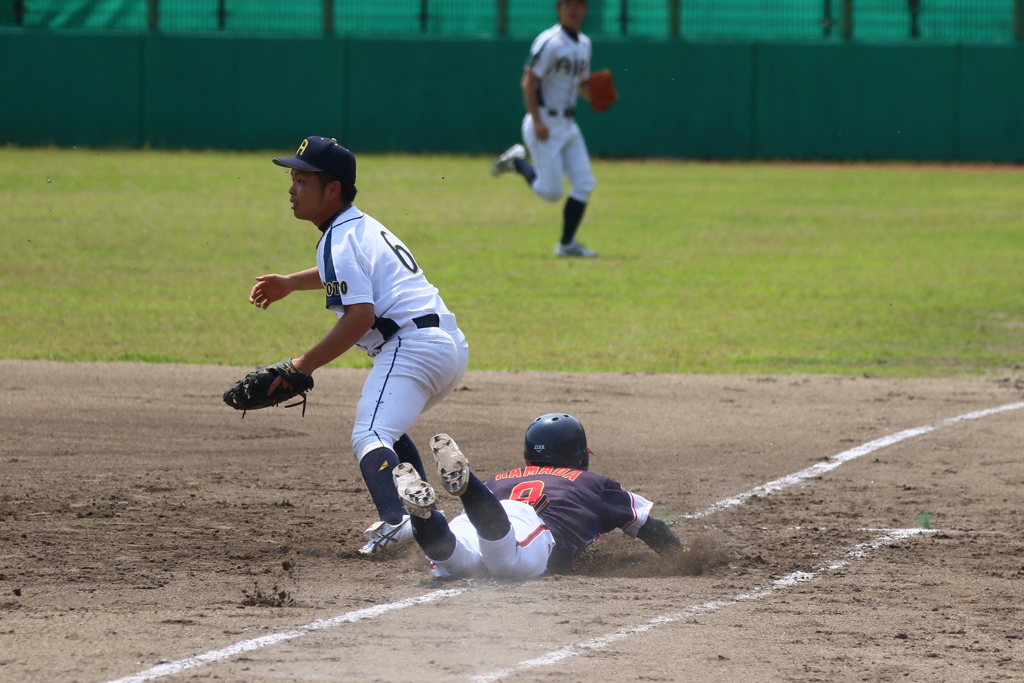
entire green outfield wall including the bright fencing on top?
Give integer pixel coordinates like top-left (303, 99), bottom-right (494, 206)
top-left (0, 0), bottom-right (1024, 164)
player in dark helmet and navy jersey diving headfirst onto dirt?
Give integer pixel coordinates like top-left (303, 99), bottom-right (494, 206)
top-left (394, 413), bottom-right (681, 579)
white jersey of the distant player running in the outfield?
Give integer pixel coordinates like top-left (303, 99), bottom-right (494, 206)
top-left (527, 24), bottom-right (591, 112)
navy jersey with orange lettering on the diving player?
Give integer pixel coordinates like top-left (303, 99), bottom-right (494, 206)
top-left (485, 465), bottom-right (653, 571)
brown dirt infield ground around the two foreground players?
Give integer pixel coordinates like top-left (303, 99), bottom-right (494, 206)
top-left (0, 360), bottom-right (1024, 683)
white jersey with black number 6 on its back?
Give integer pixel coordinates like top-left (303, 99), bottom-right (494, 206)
top-left (316, 206), bottom-right (455, 356)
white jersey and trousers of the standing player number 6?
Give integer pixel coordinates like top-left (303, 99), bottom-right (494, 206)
top-left (316, 206), bottom-right (469, 461)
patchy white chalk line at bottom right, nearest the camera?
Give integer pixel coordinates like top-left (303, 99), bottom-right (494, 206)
top-left (473, 528), bottom-right (938, 683)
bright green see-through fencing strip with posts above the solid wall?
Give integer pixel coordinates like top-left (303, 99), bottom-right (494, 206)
top-left (0, 0), bottom-right (1024, 42)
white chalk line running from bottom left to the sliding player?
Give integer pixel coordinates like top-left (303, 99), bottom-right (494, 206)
top-left (101, 588), bottom-right (468, 683)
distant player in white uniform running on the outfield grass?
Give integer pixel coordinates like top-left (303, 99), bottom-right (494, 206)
top-left (490, 0), bottom-right (597, 257)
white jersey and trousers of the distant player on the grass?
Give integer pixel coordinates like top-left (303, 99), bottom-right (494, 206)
top-left (522, 25), bottom-right (597, 204)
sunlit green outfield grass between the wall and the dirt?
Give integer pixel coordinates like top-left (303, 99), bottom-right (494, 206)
top-left (0, 148), bottom-right (1024, 376)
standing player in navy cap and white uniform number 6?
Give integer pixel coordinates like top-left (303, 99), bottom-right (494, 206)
top-left (249, 136), bottom-right (469, 555)
